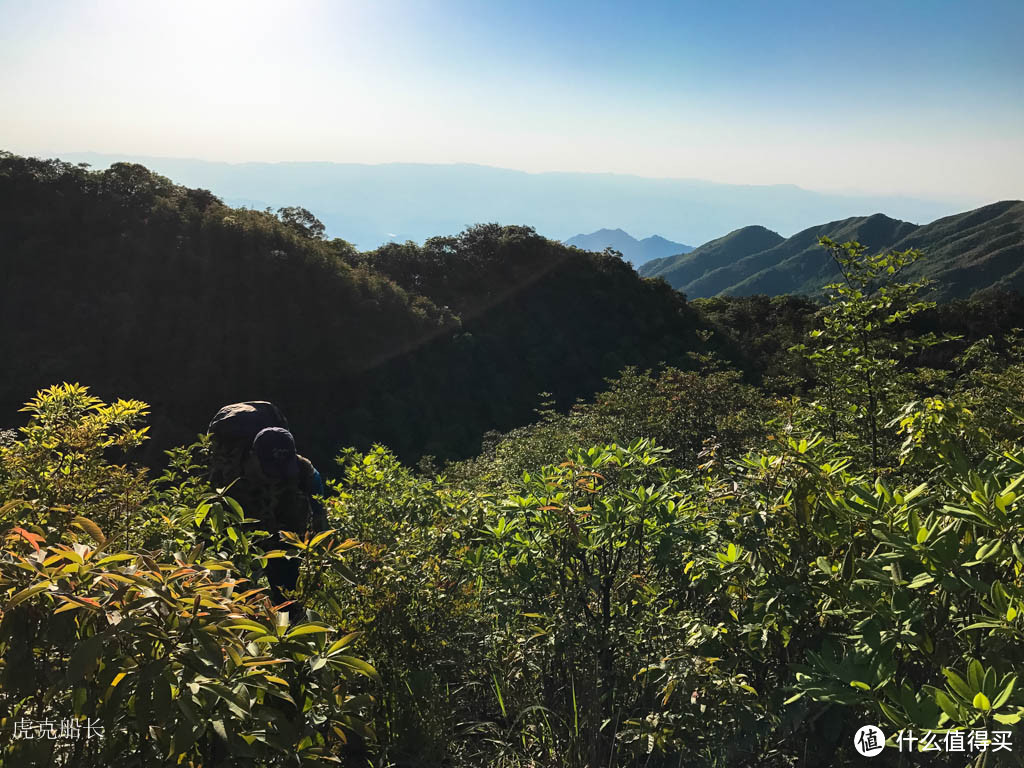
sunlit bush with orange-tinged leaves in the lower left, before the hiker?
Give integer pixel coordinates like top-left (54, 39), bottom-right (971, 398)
top-left (0, 385), bottom-right (377, 766)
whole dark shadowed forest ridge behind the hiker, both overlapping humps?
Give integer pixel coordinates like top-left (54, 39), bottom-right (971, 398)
top-left (0, 154), bottom-right (720, 459)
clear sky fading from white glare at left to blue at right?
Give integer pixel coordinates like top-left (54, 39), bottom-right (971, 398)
top-left (0, 0), bottom-right (1024, 202)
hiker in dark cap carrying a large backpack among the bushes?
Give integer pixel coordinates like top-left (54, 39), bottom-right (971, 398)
top-left (202, 401), bottom-right (327, 622)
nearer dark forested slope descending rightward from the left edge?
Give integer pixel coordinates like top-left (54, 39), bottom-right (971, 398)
top-left (0, 156), bottom-right (448, 462)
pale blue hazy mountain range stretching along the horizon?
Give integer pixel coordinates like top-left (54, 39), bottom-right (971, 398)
top-left (61, 153), bottom-right (983, 249)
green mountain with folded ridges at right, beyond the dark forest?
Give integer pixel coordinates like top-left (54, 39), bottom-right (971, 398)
top-left (639, 200), bottom-right (1024, 298)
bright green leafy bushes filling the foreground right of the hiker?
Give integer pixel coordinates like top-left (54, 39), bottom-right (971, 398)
top-left (323, 415), bottom-right (1024, 766)
